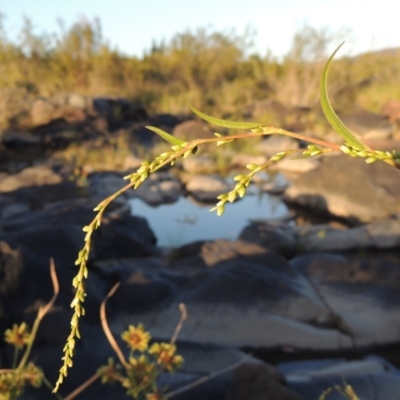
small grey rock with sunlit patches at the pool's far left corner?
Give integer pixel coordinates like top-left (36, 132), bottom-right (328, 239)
top-left (133, 172), bottom-right (182, 206)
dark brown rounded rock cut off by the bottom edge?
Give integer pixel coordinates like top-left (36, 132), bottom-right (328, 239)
top-left (225, 363), bottom-right (301, 400)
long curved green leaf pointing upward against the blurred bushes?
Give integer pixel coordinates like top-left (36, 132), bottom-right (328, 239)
top-left (319, 42), bottom-right (367, 150)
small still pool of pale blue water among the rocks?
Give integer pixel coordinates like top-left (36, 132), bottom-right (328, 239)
top-left (130, 193), bottom-right (288, 247)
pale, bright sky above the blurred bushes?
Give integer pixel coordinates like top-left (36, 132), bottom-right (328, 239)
top-left (0, 0), bottom-right (400, 57)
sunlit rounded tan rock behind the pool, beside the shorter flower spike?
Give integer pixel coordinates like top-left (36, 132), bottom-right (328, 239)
top-left (186, 175), bottom-right (231, 201)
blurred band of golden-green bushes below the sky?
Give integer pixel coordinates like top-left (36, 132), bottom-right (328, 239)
top-left (0, 18), bottom-right (400, 127)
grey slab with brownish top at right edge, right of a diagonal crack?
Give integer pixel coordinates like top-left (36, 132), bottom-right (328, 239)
top-left (290, 253), bottom-right (400, 348)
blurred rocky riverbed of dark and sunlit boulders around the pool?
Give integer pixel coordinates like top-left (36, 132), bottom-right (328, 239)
top-left (0, 94), bottom-right (400, 400)
